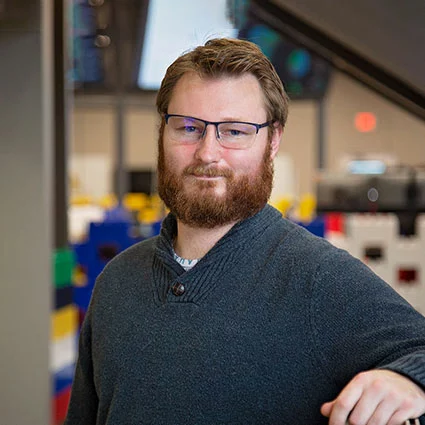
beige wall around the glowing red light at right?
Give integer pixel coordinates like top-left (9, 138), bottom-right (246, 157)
top-left (327, 74), bottom-right (425, 170)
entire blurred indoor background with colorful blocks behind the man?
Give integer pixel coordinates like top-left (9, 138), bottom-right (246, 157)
top-left (0, 0), bottom-right (425, 425)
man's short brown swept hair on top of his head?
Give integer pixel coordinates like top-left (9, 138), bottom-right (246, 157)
top-left (156, 38), bottom-right (288, 128)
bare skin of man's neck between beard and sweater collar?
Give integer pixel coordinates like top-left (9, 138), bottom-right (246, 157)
top-left (174, 220), bottom-right (236, 260)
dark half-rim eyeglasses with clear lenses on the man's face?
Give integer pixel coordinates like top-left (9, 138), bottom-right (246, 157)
top-left (164, 114), bottom-right (272, 149)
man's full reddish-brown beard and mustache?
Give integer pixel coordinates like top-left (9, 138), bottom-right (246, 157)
top-left (157, 134), bottom-right (273, 229)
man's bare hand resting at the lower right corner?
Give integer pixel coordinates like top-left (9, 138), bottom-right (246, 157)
top-left (320, 370), bottom-right (425, 425)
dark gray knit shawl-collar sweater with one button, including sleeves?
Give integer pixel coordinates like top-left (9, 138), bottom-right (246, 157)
top-left (65, 206), bottom-right (425, 425)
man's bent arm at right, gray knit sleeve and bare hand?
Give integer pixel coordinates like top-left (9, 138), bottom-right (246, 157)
top-left (313, 247), bottom-right (425, 425)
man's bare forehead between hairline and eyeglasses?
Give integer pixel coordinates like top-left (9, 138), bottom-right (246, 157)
top-left (168, 72), bottom-right (267, 122)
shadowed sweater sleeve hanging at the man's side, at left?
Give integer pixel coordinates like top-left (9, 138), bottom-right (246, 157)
top-left (64, 309), bottom-right (98, 425)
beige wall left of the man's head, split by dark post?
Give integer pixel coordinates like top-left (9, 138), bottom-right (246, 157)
top-left (70, 103), bottom-right (157, 198)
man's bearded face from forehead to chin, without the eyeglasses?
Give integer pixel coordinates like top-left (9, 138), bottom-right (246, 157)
top-left (158, 73), bottom-right (281, 228)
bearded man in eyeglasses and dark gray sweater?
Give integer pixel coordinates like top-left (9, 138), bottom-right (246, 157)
top-left (65, 39), bottom-right (425, 425)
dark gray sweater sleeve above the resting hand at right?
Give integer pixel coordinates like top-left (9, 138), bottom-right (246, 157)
top-left (310, 250), bottom-right (425, 396)
